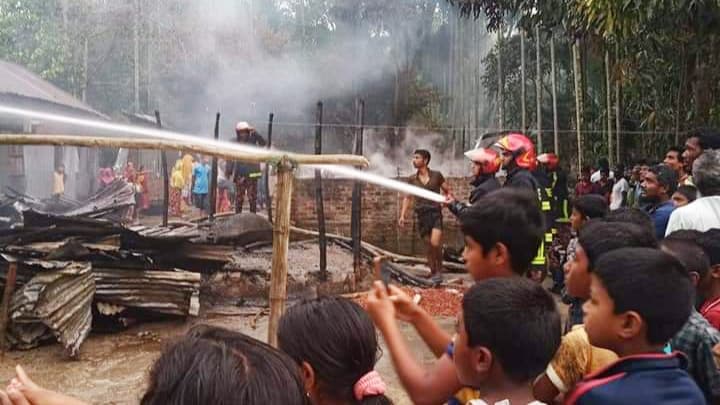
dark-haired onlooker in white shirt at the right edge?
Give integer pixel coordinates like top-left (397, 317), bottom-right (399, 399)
top-left (666, 150), bottom-right (720, 234)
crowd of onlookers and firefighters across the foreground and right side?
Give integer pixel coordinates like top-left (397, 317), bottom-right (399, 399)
top-left (5, 131), bottom-right (720, 405)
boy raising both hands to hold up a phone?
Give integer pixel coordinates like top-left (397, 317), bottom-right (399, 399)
top-left (367, 188), bottom-right (545, 404)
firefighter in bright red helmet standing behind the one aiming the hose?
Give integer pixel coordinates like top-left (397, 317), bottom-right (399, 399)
top-left (493, 133), bottom-right (551, 282)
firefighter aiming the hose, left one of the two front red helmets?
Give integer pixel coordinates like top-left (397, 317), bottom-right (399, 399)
top-left (448, 147), bottom-right (501, 217)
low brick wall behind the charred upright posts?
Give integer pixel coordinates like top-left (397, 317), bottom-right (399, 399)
top-left (291, 178), bottom-right (470, 254)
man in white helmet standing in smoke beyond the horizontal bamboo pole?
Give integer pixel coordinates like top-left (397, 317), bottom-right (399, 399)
top-left (227, 121), bottom-right (267, 214)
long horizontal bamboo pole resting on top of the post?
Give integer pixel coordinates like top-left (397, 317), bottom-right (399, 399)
top-left (0, 134), bottom-right (368, 167)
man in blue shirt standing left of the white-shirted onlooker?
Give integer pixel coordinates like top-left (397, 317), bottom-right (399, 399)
top-left (642, 165), bottom-right (677, 240)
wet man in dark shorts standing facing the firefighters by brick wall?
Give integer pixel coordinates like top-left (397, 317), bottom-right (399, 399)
top-left (398, 149), bottom-right (450, 281)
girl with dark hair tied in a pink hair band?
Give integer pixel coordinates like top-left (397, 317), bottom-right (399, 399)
top-left (278, 297), bottom-right (392, 405)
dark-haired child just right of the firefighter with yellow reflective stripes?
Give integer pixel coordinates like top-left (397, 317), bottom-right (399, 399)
top-left (562, 194), bottom-right (608, 333)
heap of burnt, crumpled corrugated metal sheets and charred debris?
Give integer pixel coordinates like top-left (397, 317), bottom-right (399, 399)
top-left (0, 181), bottom-right (272, 357)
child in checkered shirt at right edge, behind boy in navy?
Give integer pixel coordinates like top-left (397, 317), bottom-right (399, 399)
top-left (660, 234), bottom-right (720, 404)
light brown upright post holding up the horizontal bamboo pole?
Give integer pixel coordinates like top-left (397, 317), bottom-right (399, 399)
top-left (268, 157), bottom-right (293, 347)
